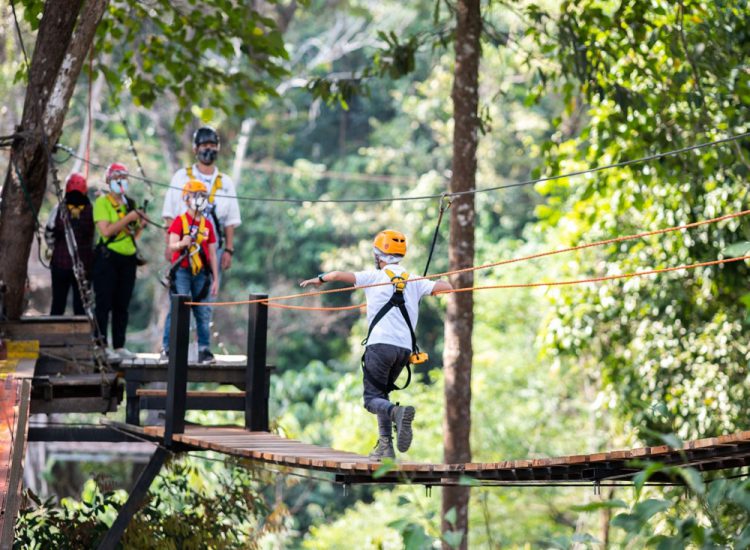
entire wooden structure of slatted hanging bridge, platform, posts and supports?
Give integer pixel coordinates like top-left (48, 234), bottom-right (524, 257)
top-left (0, 295), bottom-right (750, 548)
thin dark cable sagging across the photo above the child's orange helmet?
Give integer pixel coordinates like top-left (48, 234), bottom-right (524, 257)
top-left (57, 132), bottom-right (750, 204)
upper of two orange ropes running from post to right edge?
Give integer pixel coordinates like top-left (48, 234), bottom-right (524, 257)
top-left (186, 210), bottom-right (750, 306)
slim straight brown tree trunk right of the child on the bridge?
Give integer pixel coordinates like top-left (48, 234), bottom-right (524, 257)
top-left (442, 0), bottom-right (482, 549)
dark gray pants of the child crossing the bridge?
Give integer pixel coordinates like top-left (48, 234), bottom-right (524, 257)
top-left (362, 344), bottom-right (411, 437)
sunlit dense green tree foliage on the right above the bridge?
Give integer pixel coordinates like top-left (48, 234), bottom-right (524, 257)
top-left (536, 1), bottom-right (750, 440)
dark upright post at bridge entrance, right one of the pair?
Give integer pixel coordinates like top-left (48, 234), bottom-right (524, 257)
top-left (245, 294), bottom-right (269, 432)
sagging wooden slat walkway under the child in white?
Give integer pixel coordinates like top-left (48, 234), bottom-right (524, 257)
top-left (108, 424), bottom-right (750, 485)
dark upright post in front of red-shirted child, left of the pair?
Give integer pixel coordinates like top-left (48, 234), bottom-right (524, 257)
top-left (164, 295), bottom-right (191, 447)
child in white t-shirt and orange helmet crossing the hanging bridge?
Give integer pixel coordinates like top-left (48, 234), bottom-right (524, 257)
top-left (300, 230), bottom-right (452, 460)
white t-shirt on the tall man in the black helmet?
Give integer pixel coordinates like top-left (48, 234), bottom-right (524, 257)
top-left (161, 165), bottom-right (242, 231)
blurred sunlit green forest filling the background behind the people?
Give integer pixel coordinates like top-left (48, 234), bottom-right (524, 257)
top-left (0, 0), bottom-right (750, 548)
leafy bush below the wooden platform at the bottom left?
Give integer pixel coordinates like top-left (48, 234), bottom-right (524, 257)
top-left (14, 457), bottom-right (286, 550)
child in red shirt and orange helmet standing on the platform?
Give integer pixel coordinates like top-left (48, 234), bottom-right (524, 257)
top-left (162, 180), bottom-right (219, 364)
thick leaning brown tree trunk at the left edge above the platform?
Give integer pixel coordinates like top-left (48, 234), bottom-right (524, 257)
top-left (0, 0), bottom-right (107, 319)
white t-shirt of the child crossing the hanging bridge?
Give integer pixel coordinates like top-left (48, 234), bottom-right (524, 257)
top-left (354, 264), bottom-right (435, 350)
